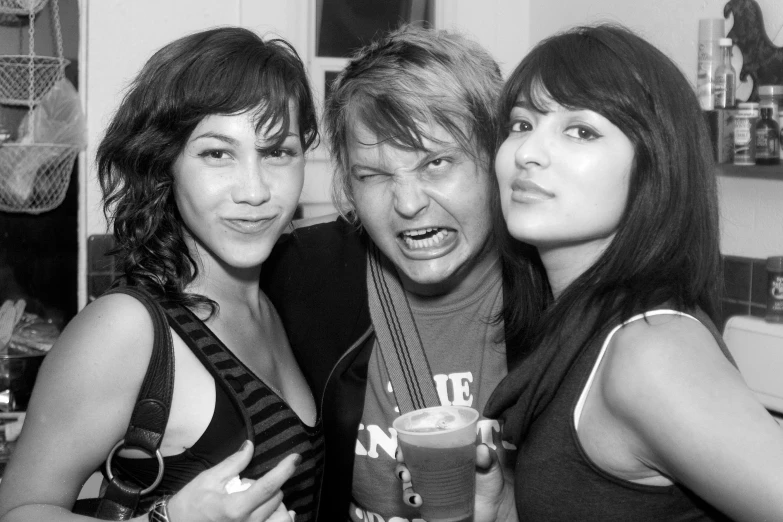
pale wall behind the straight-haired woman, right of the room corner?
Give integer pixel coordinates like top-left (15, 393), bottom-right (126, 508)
top-left (527, 0), bottom-right (783, 258)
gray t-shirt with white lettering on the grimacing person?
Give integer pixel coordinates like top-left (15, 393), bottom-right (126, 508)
top-left (350, 259), bottom-right (513, 522)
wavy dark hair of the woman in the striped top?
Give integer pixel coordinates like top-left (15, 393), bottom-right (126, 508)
top-left (96, 27), bottom-right (318, 313)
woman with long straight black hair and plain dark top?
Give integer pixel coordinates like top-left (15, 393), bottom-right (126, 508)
top-left (484, 25), bottom-right (783, 521)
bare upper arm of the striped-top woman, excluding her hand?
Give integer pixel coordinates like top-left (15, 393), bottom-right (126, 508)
top-left (0, 295), bottom-right (153, 522)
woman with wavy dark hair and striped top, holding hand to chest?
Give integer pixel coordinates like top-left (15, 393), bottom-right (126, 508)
top-left (0, 28), bottom-right (323, 522)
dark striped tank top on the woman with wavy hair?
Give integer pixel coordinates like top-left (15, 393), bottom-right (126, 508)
top-left (114, 303), bottom-right (323, 522)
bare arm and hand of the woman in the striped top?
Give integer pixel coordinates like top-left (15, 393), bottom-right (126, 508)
top-left (0, 295), bottom-right (298, 522)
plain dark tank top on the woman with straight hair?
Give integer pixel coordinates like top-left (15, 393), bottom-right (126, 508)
top-left (514, 311), bottom-right (731, 522)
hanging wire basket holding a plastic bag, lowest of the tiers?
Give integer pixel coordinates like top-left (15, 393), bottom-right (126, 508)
top-left (0, 143), bottom-right (79, 214)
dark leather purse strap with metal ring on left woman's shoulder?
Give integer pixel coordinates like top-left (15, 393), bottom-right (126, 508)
top-left (72, 286), bottom-right (174, 520)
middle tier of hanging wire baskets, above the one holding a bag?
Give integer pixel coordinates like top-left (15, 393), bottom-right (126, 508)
top-left (0, 55), bottom-right (70, 105)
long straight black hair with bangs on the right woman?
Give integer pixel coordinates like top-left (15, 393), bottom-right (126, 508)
top-left (499, 24), bottom-right (722, 362)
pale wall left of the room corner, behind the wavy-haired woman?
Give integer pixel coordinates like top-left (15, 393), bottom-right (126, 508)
top-left (79, 0), bottom-right (530, 308)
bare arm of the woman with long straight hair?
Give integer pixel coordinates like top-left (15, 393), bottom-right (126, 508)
top-left (603, 318), bottom-right (783, 521)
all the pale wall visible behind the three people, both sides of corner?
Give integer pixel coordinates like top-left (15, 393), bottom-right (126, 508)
top-left (79, 0), bottom-right (783, 307)
